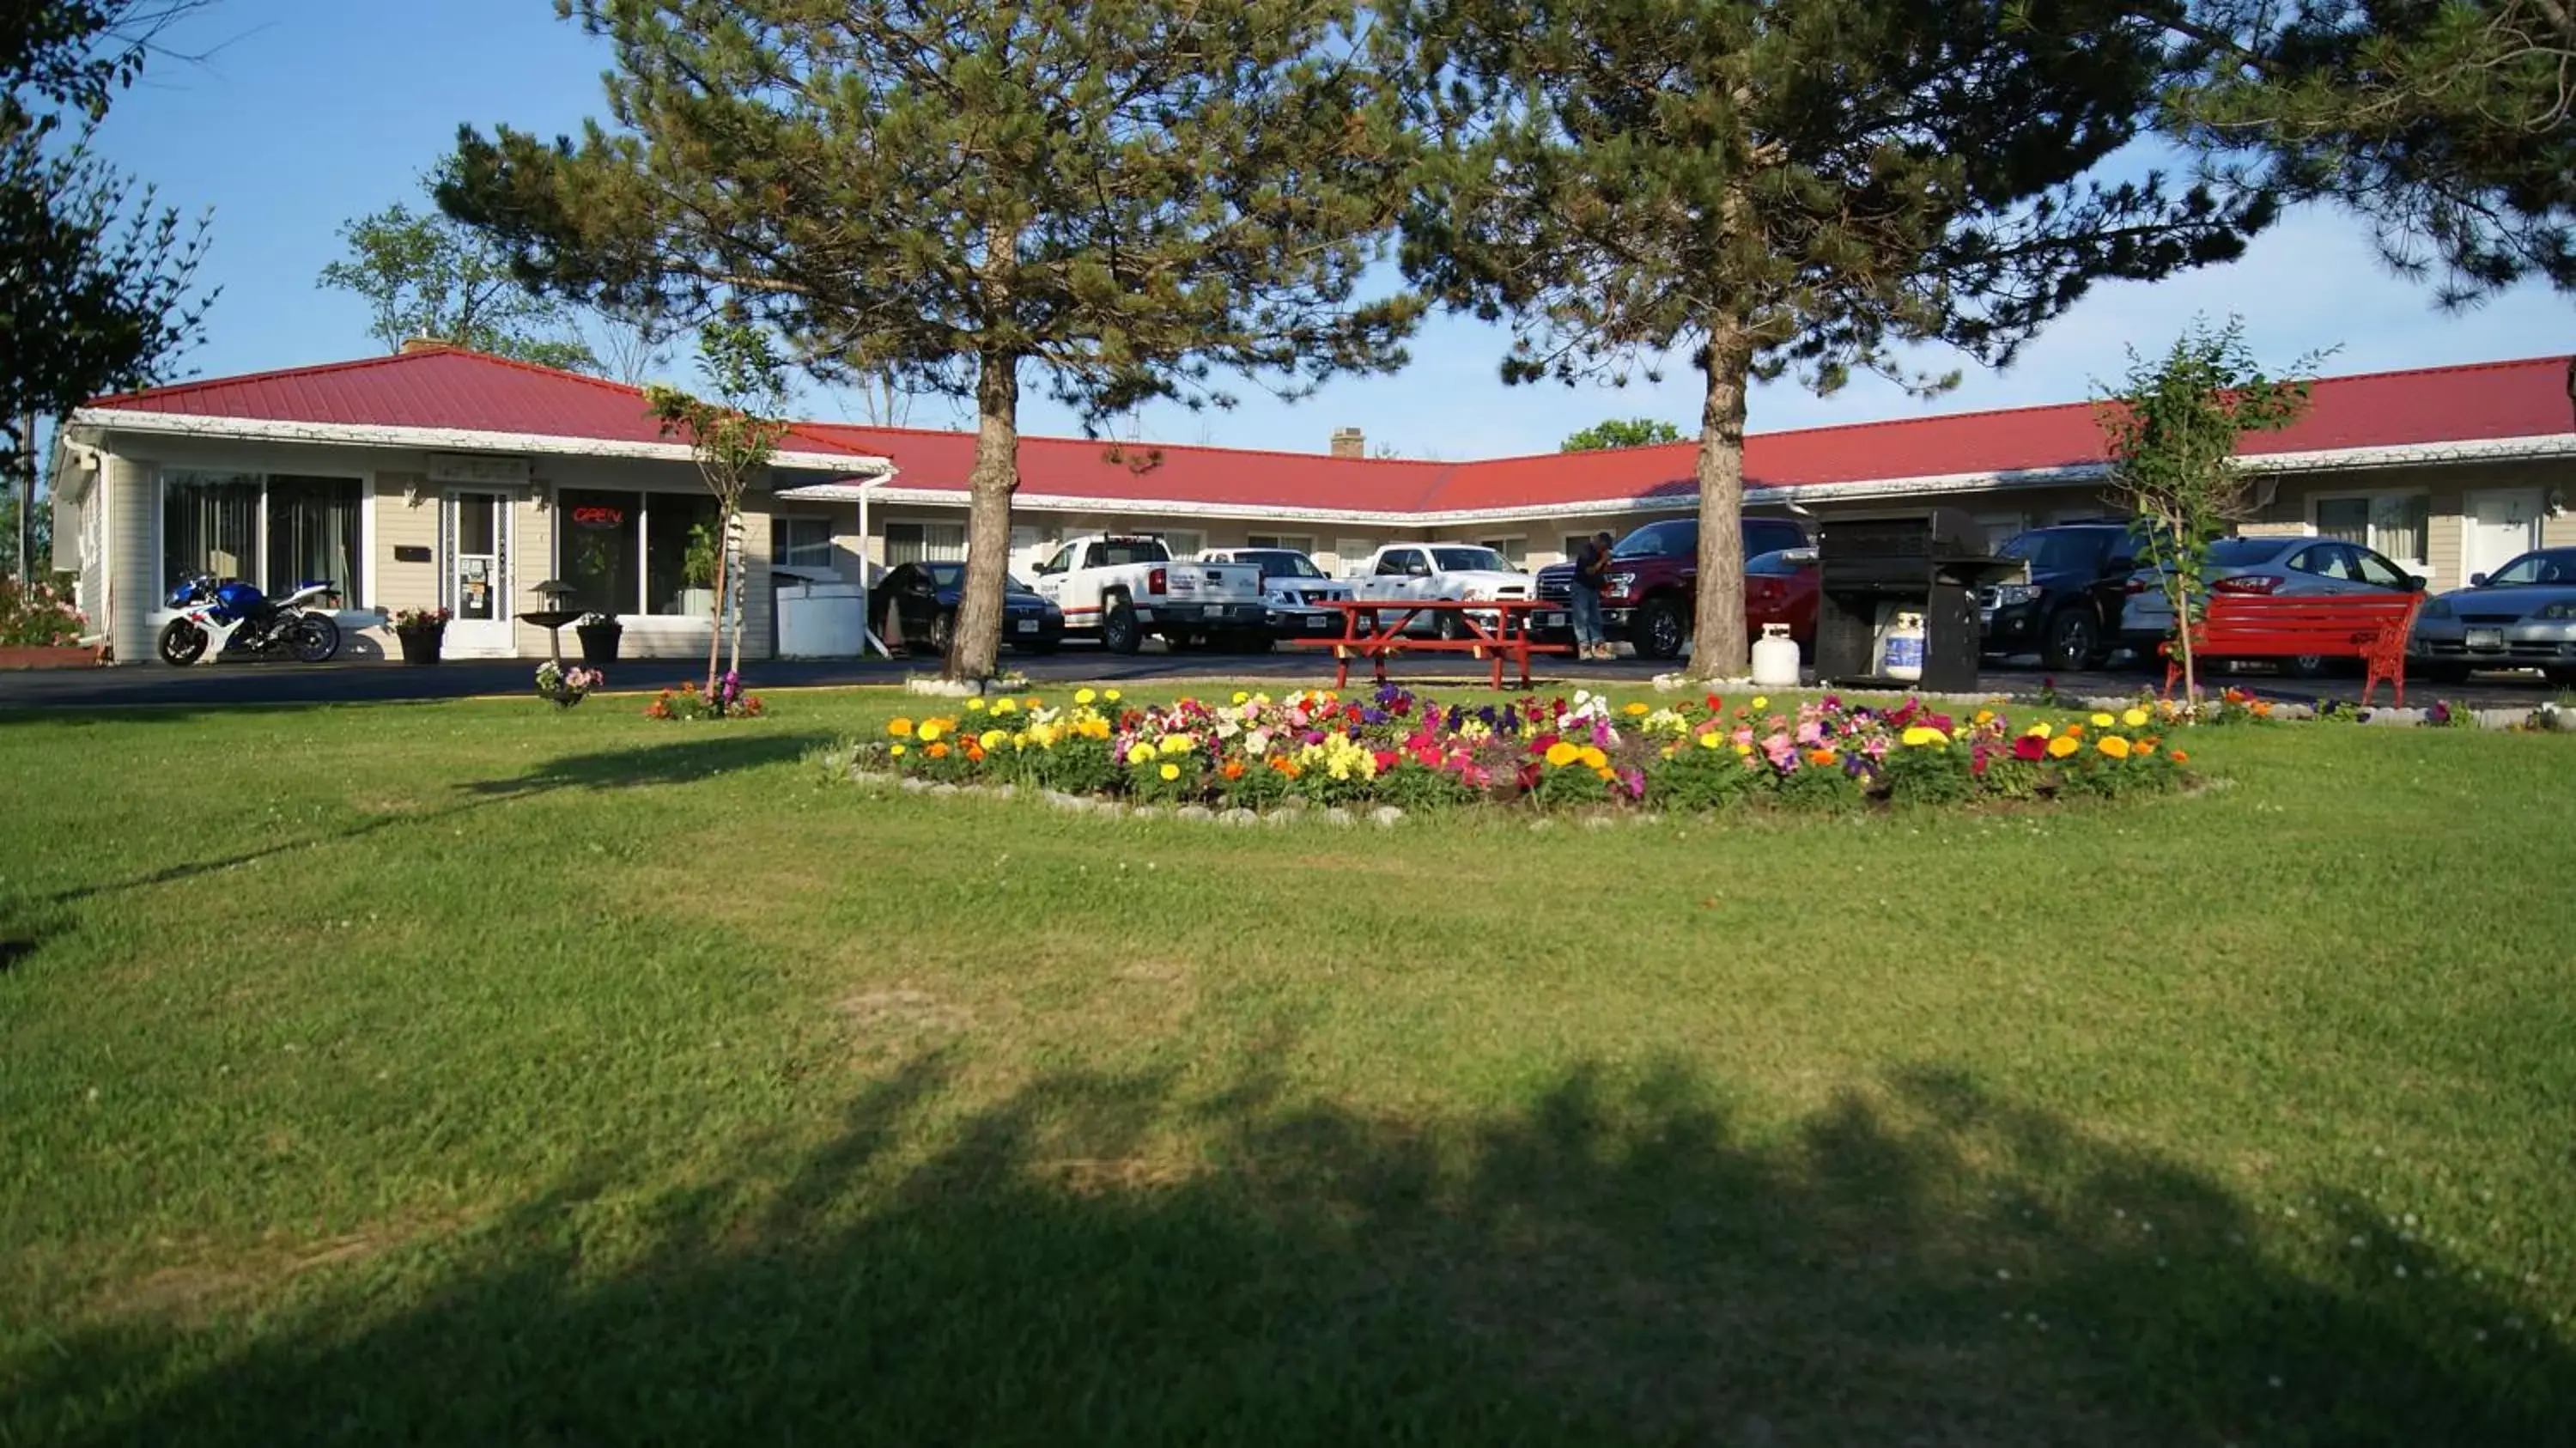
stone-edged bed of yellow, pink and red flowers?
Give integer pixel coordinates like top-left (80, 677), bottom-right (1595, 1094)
top-left (853, 685), bottom-right (2187, 812)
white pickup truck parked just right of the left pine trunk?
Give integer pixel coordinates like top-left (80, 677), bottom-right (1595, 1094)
top-left (1033, 533), bottom-right (1270, 654)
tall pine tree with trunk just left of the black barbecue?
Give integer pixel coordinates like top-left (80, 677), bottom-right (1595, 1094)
top-left (1394, 0), bottom-right (2269, 678)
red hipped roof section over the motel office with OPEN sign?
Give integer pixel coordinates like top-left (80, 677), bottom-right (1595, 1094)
top-left (90, 345), bottom-right (891, 456)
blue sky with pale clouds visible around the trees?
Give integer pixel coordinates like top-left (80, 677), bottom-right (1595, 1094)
top-left (100, 0), bottom-right (2576, 459)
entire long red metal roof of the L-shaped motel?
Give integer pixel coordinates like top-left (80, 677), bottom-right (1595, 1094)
top-left (93, 348), bottom-right (2576, 513)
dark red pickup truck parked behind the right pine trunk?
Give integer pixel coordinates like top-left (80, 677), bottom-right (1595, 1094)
top-left (1538, 518), bottom-right (1816, 660)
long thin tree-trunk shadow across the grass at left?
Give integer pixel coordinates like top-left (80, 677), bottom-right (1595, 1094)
top-left (39, 734), bottom-right (832, 902)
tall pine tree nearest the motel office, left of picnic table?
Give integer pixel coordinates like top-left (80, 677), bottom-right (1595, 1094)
top-left (440, 0), bottom-right (1419, 678)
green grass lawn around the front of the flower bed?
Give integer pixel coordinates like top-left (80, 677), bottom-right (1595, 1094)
top-left (0, 693), bottom-right (2576, 1445)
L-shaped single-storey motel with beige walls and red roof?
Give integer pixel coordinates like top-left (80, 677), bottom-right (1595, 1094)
top-left (52, 343), bottom-right (2576, 662)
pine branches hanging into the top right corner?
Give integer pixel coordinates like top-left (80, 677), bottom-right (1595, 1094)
top-left (2148, 0), bottom-right (2576, 307)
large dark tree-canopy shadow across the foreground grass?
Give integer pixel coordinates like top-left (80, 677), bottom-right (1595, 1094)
top-left (15, 1059), bottom-right (2576, 1445)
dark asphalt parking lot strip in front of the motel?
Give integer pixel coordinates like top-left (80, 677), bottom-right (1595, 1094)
top-left (0, 644), bottom-right (2558, 711)
